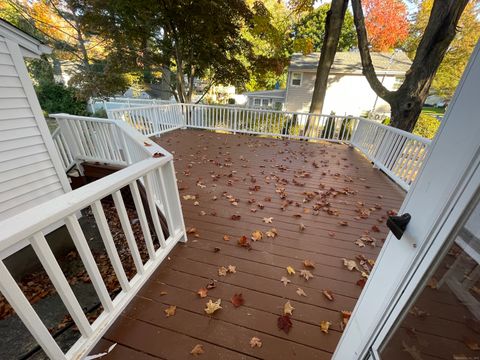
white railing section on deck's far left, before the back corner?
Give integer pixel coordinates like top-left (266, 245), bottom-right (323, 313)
top-left (107, 104), bottom-right (185, 136)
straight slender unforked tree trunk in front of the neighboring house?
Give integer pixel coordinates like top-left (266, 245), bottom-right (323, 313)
top-left (307, 0), bottom-right (348, 118)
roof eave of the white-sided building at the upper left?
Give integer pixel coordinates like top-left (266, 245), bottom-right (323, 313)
top-left (0, 19), bottom-right (52, 57)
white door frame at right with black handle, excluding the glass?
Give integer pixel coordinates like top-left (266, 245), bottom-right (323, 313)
top-left (333, 43), bottom-right (480, 360)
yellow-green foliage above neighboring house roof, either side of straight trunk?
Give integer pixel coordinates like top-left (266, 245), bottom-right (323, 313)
top-left (293, 4), bottom-right (357, 53)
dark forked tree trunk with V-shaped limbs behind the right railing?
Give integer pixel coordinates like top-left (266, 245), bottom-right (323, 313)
top-left (352, 0), bottom-right (468, 131)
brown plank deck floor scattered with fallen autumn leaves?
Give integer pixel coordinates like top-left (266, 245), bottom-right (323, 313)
top-left (92, 130), bottom-right (404, 359)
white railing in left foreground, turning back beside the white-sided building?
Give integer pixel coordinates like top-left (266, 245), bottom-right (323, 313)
top-left (0, 114), bottom-right (186, 359)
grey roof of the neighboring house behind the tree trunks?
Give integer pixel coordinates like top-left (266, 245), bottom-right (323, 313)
top-left (288, 51), bottom-right (412, 74)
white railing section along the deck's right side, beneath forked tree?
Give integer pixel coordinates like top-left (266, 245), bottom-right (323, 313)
top-left (351, 119), bottom-right (431, 190)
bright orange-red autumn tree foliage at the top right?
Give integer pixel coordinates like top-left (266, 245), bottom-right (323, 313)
top-left (362, 0), bottom-right (409, 51)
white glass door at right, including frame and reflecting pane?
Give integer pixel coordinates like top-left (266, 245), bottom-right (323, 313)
top-left (333, 44), bottom-right (480, 360)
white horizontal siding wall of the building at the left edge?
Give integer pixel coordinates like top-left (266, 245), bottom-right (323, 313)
top-left (0, 36), bottom-right (70, 221)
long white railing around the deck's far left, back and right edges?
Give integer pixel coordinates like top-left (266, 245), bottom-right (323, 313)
top-left (108, 104), bottom-right (430, 190)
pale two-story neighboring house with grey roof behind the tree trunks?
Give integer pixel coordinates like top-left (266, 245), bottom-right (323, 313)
top-left (285, 51), bottom-right (411, 116)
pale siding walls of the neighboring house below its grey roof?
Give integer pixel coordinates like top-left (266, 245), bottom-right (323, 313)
top-left (286, 71), bottom-right (395, 116)
